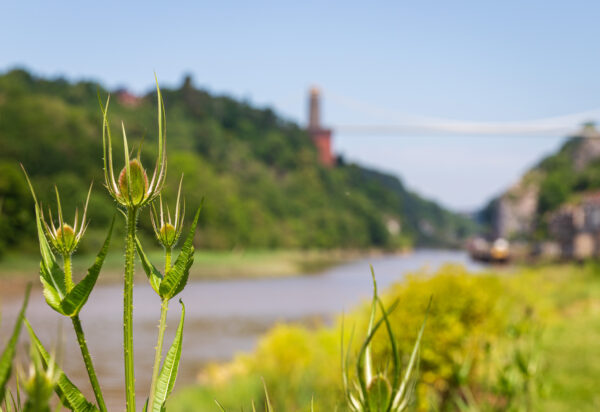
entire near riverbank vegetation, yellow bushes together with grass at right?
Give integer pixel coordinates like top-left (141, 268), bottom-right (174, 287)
top-left (171, 265), bottom-right (600, 411)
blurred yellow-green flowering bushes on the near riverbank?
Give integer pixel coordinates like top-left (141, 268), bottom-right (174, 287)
top-left (171, 266), bottom-right (543, 412)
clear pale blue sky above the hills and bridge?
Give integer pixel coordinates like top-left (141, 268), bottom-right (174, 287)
top-left (0, 0), bottom-right (600, 211)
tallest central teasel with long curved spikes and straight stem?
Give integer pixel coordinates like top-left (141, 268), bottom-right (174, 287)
top-left (99, 76), bottom-right (167, 412)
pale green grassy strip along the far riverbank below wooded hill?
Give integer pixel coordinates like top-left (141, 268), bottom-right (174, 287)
top-left (0, 248), bottom-right (364, 281)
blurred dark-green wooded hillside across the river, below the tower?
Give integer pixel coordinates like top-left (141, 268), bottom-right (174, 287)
top-left (0, 70), bottom-right (472, 253)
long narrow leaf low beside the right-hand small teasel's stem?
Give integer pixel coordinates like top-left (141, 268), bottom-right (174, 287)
top-left (151, 299), bottom-right (185, 412)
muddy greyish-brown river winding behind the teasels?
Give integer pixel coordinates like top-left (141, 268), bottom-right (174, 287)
top-left (0, 250), bottom-right (481, 410)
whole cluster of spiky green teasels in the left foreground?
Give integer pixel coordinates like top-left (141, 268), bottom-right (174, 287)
top-left (0, 81), bottom-right (201, 412)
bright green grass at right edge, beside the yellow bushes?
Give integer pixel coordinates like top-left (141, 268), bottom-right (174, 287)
top-left (538, 264), bottom-right (600, 412)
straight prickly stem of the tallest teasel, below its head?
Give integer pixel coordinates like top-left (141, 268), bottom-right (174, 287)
top-left (123, 207), bottom-right (138, 412)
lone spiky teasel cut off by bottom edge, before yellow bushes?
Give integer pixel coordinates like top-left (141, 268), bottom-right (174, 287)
top-left (341, 266), bottom-right (431, 412)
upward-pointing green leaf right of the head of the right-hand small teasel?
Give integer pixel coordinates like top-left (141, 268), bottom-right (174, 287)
top-left (159, 205), bottom-right (202, 299)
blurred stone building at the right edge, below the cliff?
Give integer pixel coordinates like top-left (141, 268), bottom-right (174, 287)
top-left (548, 192), bottom-right (600, 259)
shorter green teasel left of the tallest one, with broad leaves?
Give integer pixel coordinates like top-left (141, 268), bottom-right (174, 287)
top-left (21, 165), bottom-right (115, 412)
